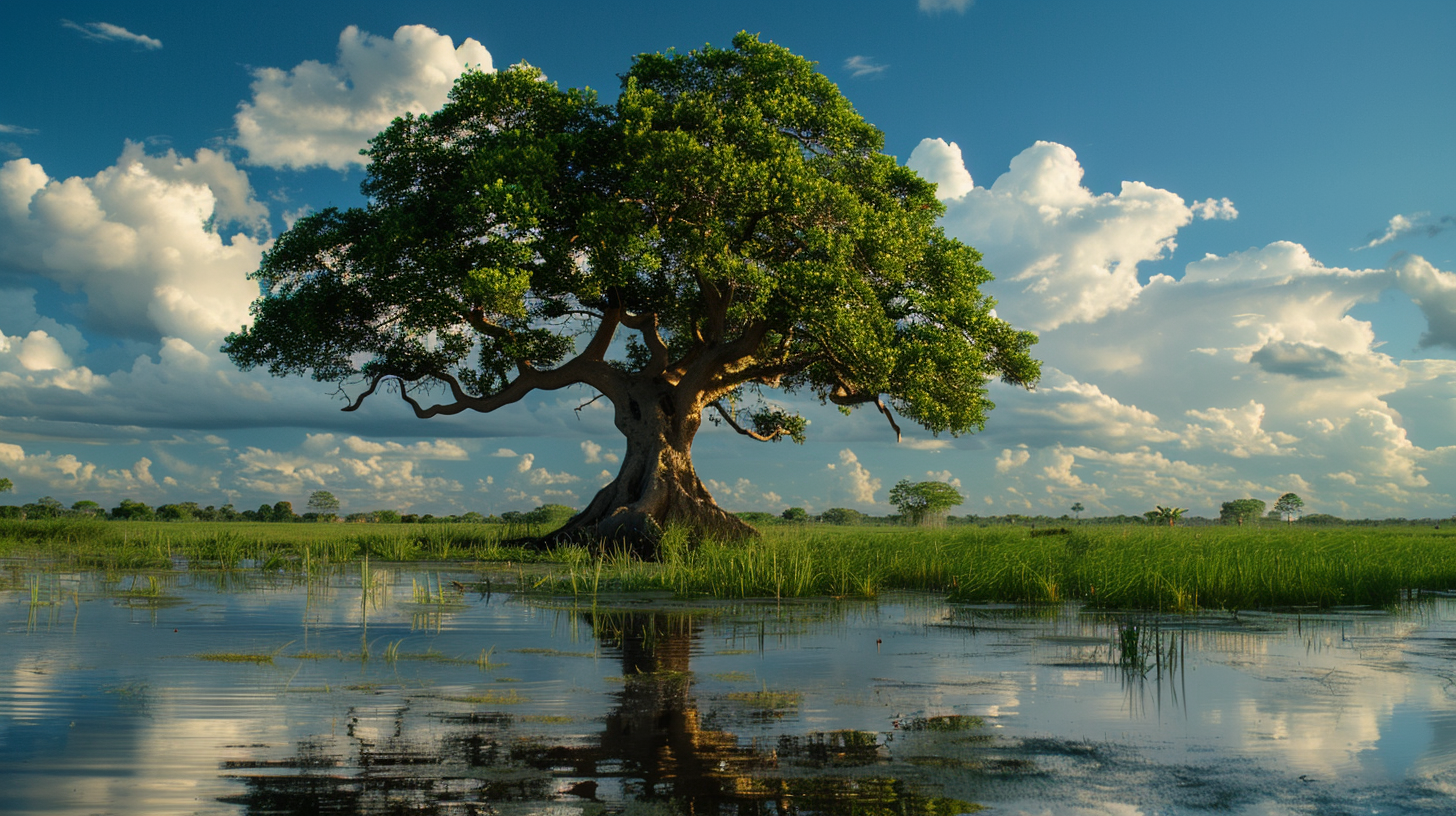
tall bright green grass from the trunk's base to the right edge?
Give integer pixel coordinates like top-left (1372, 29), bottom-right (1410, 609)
top-left (545, 527), bottom-right (1456, 612)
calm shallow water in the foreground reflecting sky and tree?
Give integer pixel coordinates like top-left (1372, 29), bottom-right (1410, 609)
top-left (0, 565), bottom-right (1456, 815)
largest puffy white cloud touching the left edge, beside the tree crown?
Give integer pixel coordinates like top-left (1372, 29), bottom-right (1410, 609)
top-left (0, 143), bottom-right (266, 345)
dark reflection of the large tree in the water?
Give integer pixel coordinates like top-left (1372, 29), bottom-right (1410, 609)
top-left (224, 612), bottom-right (980, 816)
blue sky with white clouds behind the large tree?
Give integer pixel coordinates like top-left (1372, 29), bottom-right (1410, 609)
top-left (0, 0), bottom-right (1456, 516)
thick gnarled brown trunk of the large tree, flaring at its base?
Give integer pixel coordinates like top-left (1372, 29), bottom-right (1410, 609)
top-left (543, 382), bottom-right (759, 560)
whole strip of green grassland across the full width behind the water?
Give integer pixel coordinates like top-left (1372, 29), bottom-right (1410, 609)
top-left (0, 522), bottom-right (1456, 611)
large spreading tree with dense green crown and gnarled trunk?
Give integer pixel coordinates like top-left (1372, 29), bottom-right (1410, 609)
top-left (224, 34), bottom-right (1040, 555)
